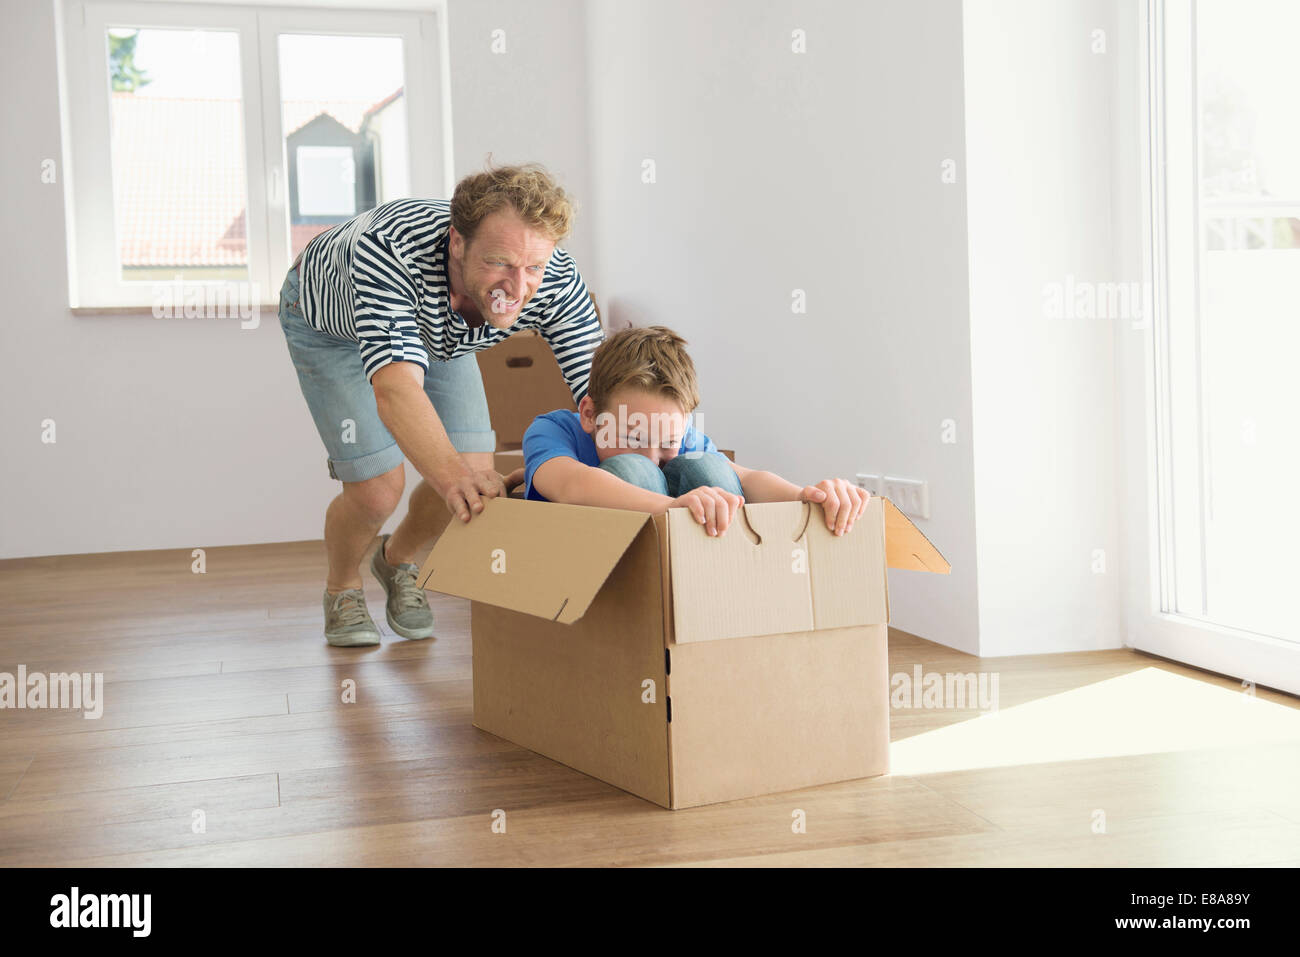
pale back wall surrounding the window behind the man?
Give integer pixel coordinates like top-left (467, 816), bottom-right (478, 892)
top-left (0, 0), bottom-right (592, 561)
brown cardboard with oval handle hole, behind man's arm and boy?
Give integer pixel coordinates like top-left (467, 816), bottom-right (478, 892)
top-left (476, 332), bottom-right (577, 451)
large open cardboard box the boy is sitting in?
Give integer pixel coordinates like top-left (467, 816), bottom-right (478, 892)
top-left (419, 498), bottom-right (949, 809)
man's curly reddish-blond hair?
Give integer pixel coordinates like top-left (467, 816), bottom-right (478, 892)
top-left (451, 163), bottom-right (576, 243)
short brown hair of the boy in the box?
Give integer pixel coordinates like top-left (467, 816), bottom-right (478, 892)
top-left (586, 325), bottom-right (699, 413)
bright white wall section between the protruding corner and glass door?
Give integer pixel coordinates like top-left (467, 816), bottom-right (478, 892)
top-left (963, 0), bottom-right (1140, 657)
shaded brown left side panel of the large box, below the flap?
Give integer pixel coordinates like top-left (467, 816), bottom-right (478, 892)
top-left (471, 522), bottom-right (668, 807)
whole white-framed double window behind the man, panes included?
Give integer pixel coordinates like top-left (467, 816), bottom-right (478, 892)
top-left (61, 0), bottom-right (451, 308)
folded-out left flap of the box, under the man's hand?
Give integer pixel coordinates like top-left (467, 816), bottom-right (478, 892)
top-left (419, 498), bottom-right (650, 624)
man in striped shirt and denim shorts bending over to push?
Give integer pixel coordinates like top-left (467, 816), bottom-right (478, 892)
top-left (280, 164), bottom-right (603, 646)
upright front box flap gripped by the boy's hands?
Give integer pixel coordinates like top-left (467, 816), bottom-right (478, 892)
top-left (667, 498), bottom-right (888, 644)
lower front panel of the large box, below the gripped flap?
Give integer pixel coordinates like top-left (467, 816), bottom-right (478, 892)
top-left (668, 624), bottom-right (889, 807)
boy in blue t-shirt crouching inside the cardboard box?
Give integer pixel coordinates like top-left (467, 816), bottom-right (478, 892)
top-left (524, 325), bottom-right (870, 536)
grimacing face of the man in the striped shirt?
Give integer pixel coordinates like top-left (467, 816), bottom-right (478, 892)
top-left (451, 209), bottom-right (555, 329)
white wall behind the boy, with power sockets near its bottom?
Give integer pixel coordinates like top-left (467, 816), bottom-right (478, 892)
top-left (588, 0), bottom-right (976, 651)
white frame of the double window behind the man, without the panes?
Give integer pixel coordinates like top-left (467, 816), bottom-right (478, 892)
top-left (60, 0), bottom-right (451, 315)
